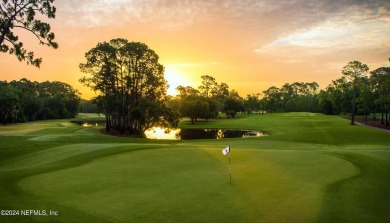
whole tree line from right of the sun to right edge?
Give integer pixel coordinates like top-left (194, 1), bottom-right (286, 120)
top-left (167, 61), bottom-right (390, 129)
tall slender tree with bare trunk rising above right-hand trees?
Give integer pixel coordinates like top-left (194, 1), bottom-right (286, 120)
top-left (342, 61), bottom-right (369, 125)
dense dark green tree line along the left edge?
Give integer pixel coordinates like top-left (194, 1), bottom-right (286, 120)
top-left (0, 78), bottom-right (80, 124)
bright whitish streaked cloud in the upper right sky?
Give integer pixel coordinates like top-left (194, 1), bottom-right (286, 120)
top-left (254, 4), bottom-right (390, 63)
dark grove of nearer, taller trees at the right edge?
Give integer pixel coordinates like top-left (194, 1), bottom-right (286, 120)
top-left (318, 61), bottom-right (390, 126)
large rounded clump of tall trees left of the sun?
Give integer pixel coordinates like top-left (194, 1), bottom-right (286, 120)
top-left (80, 39), bottom-right (178, 135)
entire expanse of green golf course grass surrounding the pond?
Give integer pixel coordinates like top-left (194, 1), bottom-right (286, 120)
top-left (0, 113), bottom-right (390, 222)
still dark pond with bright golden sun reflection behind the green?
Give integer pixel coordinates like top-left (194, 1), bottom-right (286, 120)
top-left (145, 127), bottom-right (268, 140)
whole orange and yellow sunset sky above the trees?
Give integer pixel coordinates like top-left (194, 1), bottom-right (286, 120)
top-left (0, 0), bottom-right (390, 98)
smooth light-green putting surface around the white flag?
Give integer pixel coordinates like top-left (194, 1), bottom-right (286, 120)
top-left (18, 147), bottom-right (356, 222)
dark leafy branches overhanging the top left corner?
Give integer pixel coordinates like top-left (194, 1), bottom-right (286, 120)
top-left (0, 0), bottom-right (58, 67)
